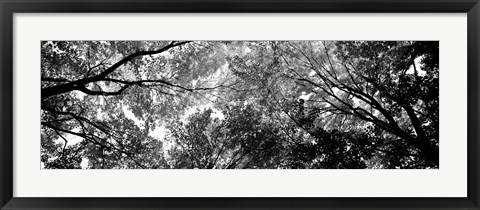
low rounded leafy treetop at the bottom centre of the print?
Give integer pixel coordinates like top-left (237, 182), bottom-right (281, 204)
top-left (165, 105), bottom-right (286, 169)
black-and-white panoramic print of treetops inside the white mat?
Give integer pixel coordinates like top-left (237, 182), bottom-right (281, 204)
top-left (40, 40), bottom-right (439, 169)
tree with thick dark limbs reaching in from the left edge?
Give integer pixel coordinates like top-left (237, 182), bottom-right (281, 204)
top-left (41, 41), bottom-right (232, 168)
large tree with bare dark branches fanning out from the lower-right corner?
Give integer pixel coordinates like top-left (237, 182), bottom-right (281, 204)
top-left (229, 42), bottom-right (439, 167)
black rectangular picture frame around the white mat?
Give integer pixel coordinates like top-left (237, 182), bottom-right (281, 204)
top-left (0, 0), bottom-right (480, 210)
